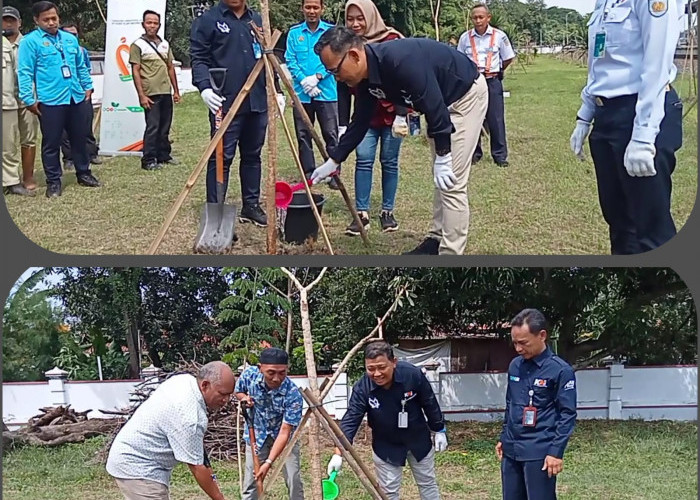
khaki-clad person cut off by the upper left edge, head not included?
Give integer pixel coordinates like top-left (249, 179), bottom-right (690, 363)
top-left (2, 33), bottom-right (33, 196)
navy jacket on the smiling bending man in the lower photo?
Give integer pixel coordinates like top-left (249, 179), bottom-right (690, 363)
top-left (340, 361), bottom-right (445, 466)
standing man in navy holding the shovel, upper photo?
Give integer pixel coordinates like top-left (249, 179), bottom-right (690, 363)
top-left (190, 0), bottom-right (285, 227)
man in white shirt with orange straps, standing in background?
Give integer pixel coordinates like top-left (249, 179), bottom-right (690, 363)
top-left (457, 4), bottom-right (515, 167)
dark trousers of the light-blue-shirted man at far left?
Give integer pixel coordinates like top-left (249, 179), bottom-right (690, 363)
top-left (39, 101), bottom-right (92, 184)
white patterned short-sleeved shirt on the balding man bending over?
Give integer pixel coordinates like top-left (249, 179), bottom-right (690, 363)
top-left (107, 374), bottom-right (208, 486)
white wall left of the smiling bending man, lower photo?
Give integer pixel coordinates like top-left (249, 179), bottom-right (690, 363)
top-left (2, 373), bottom-right (349, 430)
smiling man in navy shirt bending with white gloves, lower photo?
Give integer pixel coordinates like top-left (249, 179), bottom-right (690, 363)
top-left (328, 342), bottom-right (447, 500)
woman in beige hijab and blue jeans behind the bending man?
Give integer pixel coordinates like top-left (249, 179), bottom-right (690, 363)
top-left (338, 0), bottom-right (409, 236)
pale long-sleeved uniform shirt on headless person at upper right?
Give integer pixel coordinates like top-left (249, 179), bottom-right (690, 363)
top-left (578, 0), bottom-right (685, 143)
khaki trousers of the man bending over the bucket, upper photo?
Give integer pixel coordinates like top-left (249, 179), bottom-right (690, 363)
top-left (428, 75), bottom-right (489, 255)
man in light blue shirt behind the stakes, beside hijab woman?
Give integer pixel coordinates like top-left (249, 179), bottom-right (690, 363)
top-left (284, 0), bottom-right (338, 174)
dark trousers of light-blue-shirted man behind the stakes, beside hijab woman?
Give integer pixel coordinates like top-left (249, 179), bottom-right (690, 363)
top-left (293, 99), bottom-right (338, 175)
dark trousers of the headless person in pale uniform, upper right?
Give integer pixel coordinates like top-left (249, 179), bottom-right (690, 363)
top-left (589, 89), bottom-right (683, 254)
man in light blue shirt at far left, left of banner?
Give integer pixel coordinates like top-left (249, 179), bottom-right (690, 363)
top-left (17, 1), bottom-right (100, 198)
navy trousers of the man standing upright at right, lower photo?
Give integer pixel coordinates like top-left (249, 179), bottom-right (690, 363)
top-left (501, 455), bottom-right (557, 500)
